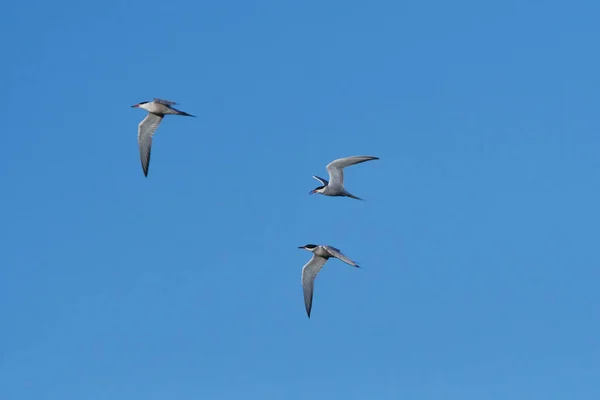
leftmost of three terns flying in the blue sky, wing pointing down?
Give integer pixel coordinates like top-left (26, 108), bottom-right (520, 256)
top-left (131, 98), bottom-right (195, 177)
